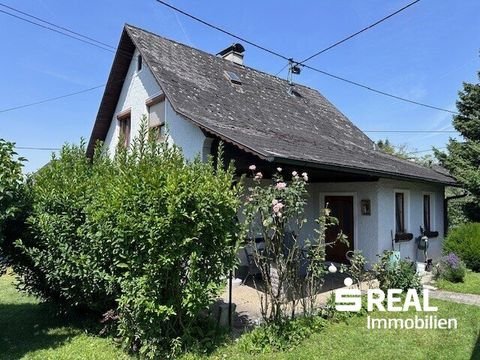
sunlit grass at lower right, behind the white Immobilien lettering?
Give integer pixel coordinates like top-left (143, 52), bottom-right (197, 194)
top-left (187, 300), bottom-right (480, 360)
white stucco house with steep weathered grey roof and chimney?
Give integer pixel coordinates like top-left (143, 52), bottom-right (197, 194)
top-left (88, 25), bottom-right (454, 268)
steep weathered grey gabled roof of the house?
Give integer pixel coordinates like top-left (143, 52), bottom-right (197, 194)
top-left (88, 25), bottom-right (454, 184)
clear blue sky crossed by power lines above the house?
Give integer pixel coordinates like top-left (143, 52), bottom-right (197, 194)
top-left (0, 0), bottom-right (480, 171)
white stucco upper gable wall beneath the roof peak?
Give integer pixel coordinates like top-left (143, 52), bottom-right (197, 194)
top-left (105, 51), bottom-right (206, 160)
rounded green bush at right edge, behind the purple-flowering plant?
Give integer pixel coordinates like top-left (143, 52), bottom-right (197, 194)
top-left (443, 223), bottom-right (480, 272)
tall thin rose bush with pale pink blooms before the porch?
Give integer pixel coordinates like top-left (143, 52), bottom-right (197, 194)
top-left (244, 165), bottom-right (345, 322)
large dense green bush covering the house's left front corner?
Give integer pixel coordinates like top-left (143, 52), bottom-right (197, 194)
top-left (16, 123), bottom-right (240, 358)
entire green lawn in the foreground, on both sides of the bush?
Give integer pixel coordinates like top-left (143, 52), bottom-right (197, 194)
top-left (0, 275), bottom-right (480, 360)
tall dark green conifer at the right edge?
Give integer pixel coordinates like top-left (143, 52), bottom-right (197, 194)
top-left (435, 72), bottom-right (480, 221)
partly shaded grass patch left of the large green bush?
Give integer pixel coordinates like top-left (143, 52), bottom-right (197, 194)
top-left (0, 274), bottom-right (129, 360)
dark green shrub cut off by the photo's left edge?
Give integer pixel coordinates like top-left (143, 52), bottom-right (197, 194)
top-left (0, 139), bottom-right (29, 275)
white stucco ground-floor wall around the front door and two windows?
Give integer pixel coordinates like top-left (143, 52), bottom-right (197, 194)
top-left (239, 179), bottom-right (444, 266)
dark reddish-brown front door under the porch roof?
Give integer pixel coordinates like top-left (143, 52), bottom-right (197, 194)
top-left (325, 196), bottom-right (354, 263)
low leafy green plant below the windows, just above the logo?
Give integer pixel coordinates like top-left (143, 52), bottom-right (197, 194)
top-left (373, 251), bottom-right (421, 291)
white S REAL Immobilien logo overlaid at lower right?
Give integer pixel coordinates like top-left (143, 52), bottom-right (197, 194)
top-left (335, 278), bottom-right (458, 330)
